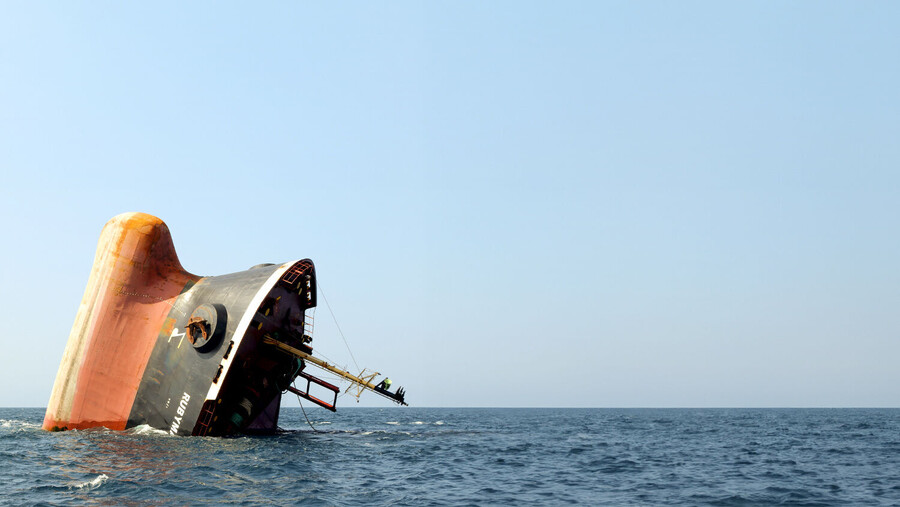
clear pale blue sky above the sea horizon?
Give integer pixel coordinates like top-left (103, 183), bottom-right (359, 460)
top-left (0, 1), bottom-right (900, 407)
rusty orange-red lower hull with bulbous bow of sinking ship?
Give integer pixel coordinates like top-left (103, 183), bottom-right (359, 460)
top-left (43, 213), bottom-right (200, 430)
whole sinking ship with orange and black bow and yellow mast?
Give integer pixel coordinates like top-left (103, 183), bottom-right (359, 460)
top-left (43, 213), bottom-right (406, 436)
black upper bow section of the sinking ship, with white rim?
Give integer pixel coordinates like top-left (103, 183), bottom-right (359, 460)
top-left (127, 259), bottom-right (316, 435)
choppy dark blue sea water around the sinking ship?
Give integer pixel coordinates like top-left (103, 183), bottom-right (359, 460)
top-left (0, 408), bottom-right (900, 506)
